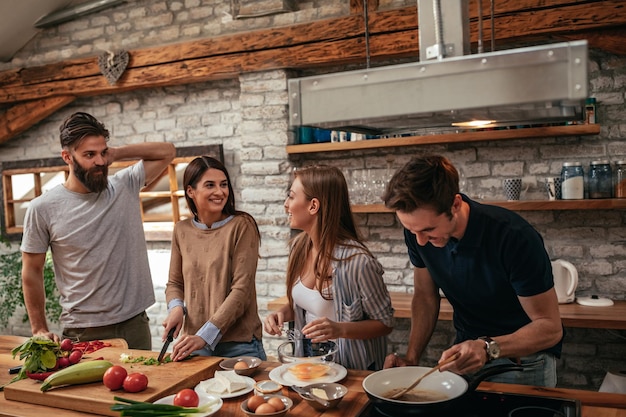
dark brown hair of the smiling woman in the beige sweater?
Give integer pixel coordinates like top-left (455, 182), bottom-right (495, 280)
top-left (183, 155), bottom-right (261, 241)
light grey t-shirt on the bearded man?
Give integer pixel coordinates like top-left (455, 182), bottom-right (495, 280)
top-left (20, 161), bottom-right (155, 328)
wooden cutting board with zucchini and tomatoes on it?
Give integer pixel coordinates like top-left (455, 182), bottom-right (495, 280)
top-left (4, 347), bottom-right (222, 416)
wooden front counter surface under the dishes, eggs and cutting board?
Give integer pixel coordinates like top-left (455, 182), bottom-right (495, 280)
top-left (0, 336), bottom-right (626, 417)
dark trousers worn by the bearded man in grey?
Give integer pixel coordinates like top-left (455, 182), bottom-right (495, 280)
top-left (63, 311), bottom-right (152, 350)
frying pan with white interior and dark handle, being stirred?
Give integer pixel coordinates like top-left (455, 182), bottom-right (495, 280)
top-left (363, 364), bottom-right (523, 416)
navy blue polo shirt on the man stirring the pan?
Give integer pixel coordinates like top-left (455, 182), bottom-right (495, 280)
top-left (404, 194), bottom-right (562, 357)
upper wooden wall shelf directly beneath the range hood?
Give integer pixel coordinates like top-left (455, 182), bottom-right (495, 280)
top-left (287, 124), bottom-right (600, 155)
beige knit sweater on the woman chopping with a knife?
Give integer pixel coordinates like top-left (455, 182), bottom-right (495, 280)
top-left (165, 215), bottom-right (262, 342)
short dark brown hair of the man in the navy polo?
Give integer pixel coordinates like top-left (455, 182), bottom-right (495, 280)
top-left (382, 155), bottom-right (459, 215)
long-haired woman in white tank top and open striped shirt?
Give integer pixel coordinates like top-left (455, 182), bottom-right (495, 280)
top-left (264, 165), bottom-right (393, 370)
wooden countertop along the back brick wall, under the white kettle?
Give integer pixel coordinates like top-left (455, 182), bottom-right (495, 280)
top-left (267, 292), bottom-right (626, 330)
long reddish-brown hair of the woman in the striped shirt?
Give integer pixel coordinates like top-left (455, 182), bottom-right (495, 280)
top-left (287, 165), bottom-right (371, 305)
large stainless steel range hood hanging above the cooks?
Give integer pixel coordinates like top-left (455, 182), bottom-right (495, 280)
top-left (288, 0), bottom-right (588, 134)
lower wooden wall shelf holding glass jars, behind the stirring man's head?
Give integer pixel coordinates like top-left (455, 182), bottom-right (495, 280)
top-left (352, 198), bottom-right (626, 213)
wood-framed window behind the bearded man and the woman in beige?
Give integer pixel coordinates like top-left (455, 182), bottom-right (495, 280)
top-left (0, 145), bottom-right (224, 240)
